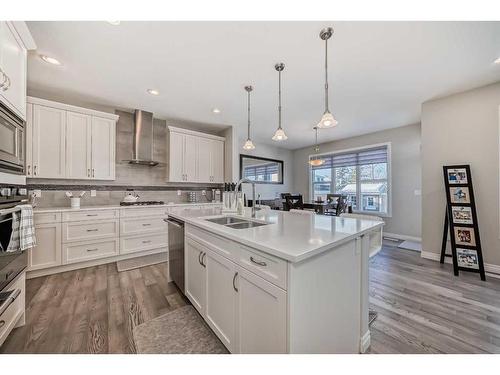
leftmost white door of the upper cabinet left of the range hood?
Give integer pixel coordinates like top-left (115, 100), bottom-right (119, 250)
top-left (32, 104), bottom-right (66, 178)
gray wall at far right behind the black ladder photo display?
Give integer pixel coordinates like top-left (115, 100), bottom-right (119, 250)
top-left (422, 82), bottom-right (500, 265)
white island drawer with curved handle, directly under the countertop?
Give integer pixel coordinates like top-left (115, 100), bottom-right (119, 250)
top-left (237, 244), bottom-right (287, 290)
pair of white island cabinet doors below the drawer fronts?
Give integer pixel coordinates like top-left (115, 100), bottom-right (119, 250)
top-left (185, 236), bottom-right (287, 353)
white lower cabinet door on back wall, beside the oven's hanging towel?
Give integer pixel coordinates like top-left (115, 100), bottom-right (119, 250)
top-left (28, 223), bottom-right (62, 271)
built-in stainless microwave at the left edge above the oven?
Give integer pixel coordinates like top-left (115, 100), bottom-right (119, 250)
top-left (0, 102), bottom-right (26, 176)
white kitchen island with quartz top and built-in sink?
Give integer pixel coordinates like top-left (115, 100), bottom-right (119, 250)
top-left (169, 208), bottom-right (383, 353)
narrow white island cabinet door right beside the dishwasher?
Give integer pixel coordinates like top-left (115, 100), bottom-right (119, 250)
top-left (184, 238), bottom-right (206, 317)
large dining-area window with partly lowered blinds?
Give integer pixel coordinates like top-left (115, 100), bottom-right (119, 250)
top-left (310, 144), bottom-right (390, 214)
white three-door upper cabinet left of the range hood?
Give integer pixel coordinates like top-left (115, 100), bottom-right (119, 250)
top-left (26, 97), bottom-right (118, 180)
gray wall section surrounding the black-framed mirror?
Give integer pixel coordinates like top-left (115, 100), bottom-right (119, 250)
top-left (237, 139), bottom-right (294, 199)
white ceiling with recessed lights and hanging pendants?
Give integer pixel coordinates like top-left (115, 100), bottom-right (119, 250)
top-left (28, 22), bottom-right (500, 149)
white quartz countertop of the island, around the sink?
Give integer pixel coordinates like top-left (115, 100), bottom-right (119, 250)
top-left (169, 207), bottom-right (384, 262)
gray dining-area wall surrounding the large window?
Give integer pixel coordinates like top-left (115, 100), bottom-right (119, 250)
top-left (293, 124), bottom-right (421, 238)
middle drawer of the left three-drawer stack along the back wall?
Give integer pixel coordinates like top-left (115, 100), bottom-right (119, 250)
top-left (62, 219), bottom-right (118, 243)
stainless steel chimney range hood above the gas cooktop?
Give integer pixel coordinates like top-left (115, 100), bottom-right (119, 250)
top-left (126, 109), bottom-right (159, 167)
